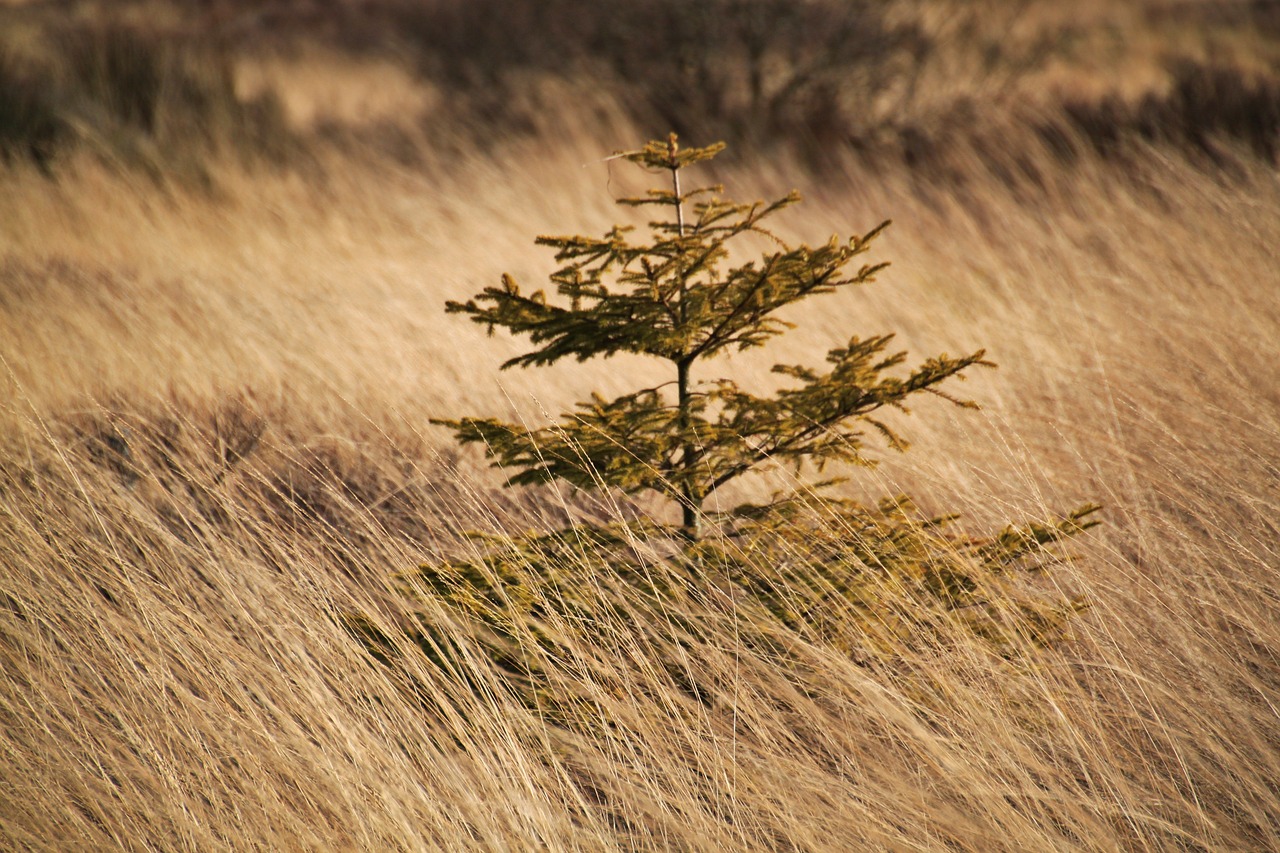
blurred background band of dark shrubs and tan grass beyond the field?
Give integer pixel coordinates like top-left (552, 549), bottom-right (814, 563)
top-left (0, 0), bottom-right (1280, 183)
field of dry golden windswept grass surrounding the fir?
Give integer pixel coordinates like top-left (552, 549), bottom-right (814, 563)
top-left (0, 0), bottom-right (1280, 850)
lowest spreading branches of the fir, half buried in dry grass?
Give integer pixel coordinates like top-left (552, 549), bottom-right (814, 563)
top-left (347, 498), bottom-right (1097, 730)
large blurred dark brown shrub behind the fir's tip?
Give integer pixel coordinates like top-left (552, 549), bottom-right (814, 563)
top-left (397, 0), bottom-right (927, 147)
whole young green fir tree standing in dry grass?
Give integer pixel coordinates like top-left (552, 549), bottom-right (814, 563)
top-left (347, 136), bottom-right (1097, 701)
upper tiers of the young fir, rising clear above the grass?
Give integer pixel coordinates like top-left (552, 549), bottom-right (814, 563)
top-left (434, 134), bottom-right (989, 540)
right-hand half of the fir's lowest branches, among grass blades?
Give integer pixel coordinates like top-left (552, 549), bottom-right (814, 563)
top-left (713, 497), bottom-right (1098, 650)
